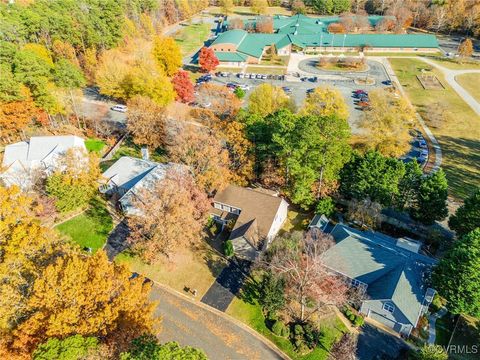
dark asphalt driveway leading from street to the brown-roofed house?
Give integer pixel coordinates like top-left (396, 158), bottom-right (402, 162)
top-left (201, 261), bottom-right (250, 311)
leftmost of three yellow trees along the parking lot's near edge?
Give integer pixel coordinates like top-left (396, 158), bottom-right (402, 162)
top-left (248, 83), bottom-right (293, 117)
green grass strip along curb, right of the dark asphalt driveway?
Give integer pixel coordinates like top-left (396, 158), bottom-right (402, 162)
top-left (227, 297), bottom-right (347, 360)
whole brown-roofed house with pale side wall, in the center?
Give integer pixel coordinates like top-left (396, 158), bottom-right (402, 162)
top-left (212, 185), bottom-right (288, 261)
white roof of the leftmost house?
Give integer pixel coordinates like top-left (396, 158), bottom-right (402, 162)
top-left (3, 135), bottom-right (85, 167)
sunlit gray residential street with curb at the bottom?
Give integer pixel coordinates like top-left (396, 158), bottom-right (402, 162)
top-left (151, 286), bottom-right (283, 360)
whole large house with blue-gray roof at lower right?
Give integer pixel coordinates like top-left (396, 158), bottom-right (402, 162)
top-left (316, 224), bottom-right (436, 336)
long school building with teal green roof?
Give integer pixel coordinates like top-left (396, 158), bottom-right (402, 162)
top-left (210, 14), bottom-right (439, 66)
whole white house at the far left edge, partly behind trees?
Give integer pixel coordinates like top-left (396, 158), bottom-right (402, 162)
top-left (0, 135), bottom-right (86, 190)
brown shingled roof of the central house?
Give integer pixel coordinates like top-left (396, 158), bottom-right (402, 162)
top-left (213, 185), bottom-right (284, 247)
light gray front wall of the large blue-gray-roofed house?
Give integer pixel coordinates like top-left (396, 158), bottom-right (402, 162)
top-left (360, 300), bottom-right (413, 335)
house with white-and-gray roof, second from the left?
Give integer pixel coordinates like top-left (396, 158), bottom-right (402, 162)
top-left (100, 156), bottom-right (182, 215)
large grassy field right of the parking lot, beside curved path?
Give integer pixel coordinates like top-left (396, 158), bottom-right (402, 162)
top-left (389, 59), bottom-right (480, 199)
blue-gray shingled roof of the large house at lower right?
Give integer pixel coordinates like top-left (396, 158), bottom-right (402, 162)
top-left (324, 224), bottom-right (436, 325)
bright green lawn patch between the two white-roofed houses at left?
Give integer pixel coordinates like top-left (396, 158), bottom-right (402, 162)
top-left (56, 200), bottom-right (113, 252)
